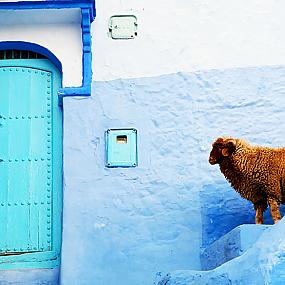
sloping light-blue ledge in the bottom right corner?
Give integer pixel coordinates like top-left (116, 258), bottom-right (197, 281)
top-left (157, 219), bottom-right (285, 285)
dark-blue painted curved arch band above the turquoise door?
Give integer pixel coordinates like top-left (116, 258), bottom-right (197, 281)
top-left (0, 41), bottom-right (62, 74)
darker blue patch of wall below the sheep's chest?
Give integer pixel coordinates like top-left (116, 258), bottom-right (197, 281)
top-left (200, 183), bottom-right (285, 248)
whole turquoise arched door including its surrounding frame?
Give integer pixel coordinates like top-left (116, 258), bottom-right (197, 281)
top-left (0, 59), bottom-right (62, 269)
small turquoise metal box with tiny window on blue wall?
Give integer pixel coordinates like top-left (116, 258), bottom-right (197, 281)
top-left (106, 129), bottom-right (138, 167)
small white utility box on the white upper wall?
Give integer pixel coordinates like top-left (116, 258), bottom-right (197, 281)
top-left (109, 15), bottom-right (137, 40)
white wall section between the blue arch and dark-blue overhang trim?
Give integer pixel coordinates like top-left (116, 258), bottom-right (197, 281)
top-left (0, 9), bottom-right (82, 87)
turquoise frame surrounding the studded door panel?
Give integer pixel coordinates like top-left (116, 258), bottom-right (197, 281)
top-left (0, 58), bottom-right (63, 270)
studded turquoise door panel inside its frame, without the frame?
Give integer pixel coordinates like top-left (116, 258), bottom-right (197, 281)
top-left (0, 66), bottom-right (52, 255)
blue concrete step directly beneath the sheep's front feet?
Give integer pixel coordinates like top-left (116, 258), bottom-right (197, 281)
top-left (201, 224), bottom-right (272, 270)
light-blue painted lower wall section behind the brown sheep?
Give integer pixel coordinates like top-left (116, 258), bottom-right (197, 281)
top-left (61, 66), bottom-right (285, 285)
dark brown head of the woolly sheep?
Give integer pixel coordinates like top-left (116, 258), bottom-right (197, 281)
top-left (209, 138), bottom-right (236, 165)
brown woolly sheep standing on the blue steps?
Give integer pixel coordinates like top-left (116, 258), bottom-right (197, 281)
top-left (209, 137), bottom-right (285, 224)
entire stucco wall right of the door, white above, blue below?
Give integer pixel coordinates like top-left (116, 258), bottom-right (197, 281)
top-left (58, 0), bottom-right (285, 285)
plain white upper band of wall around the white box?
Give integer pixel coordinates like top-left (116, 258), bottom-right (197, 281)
top-left (93, 0), bottom-right (285, 80)
